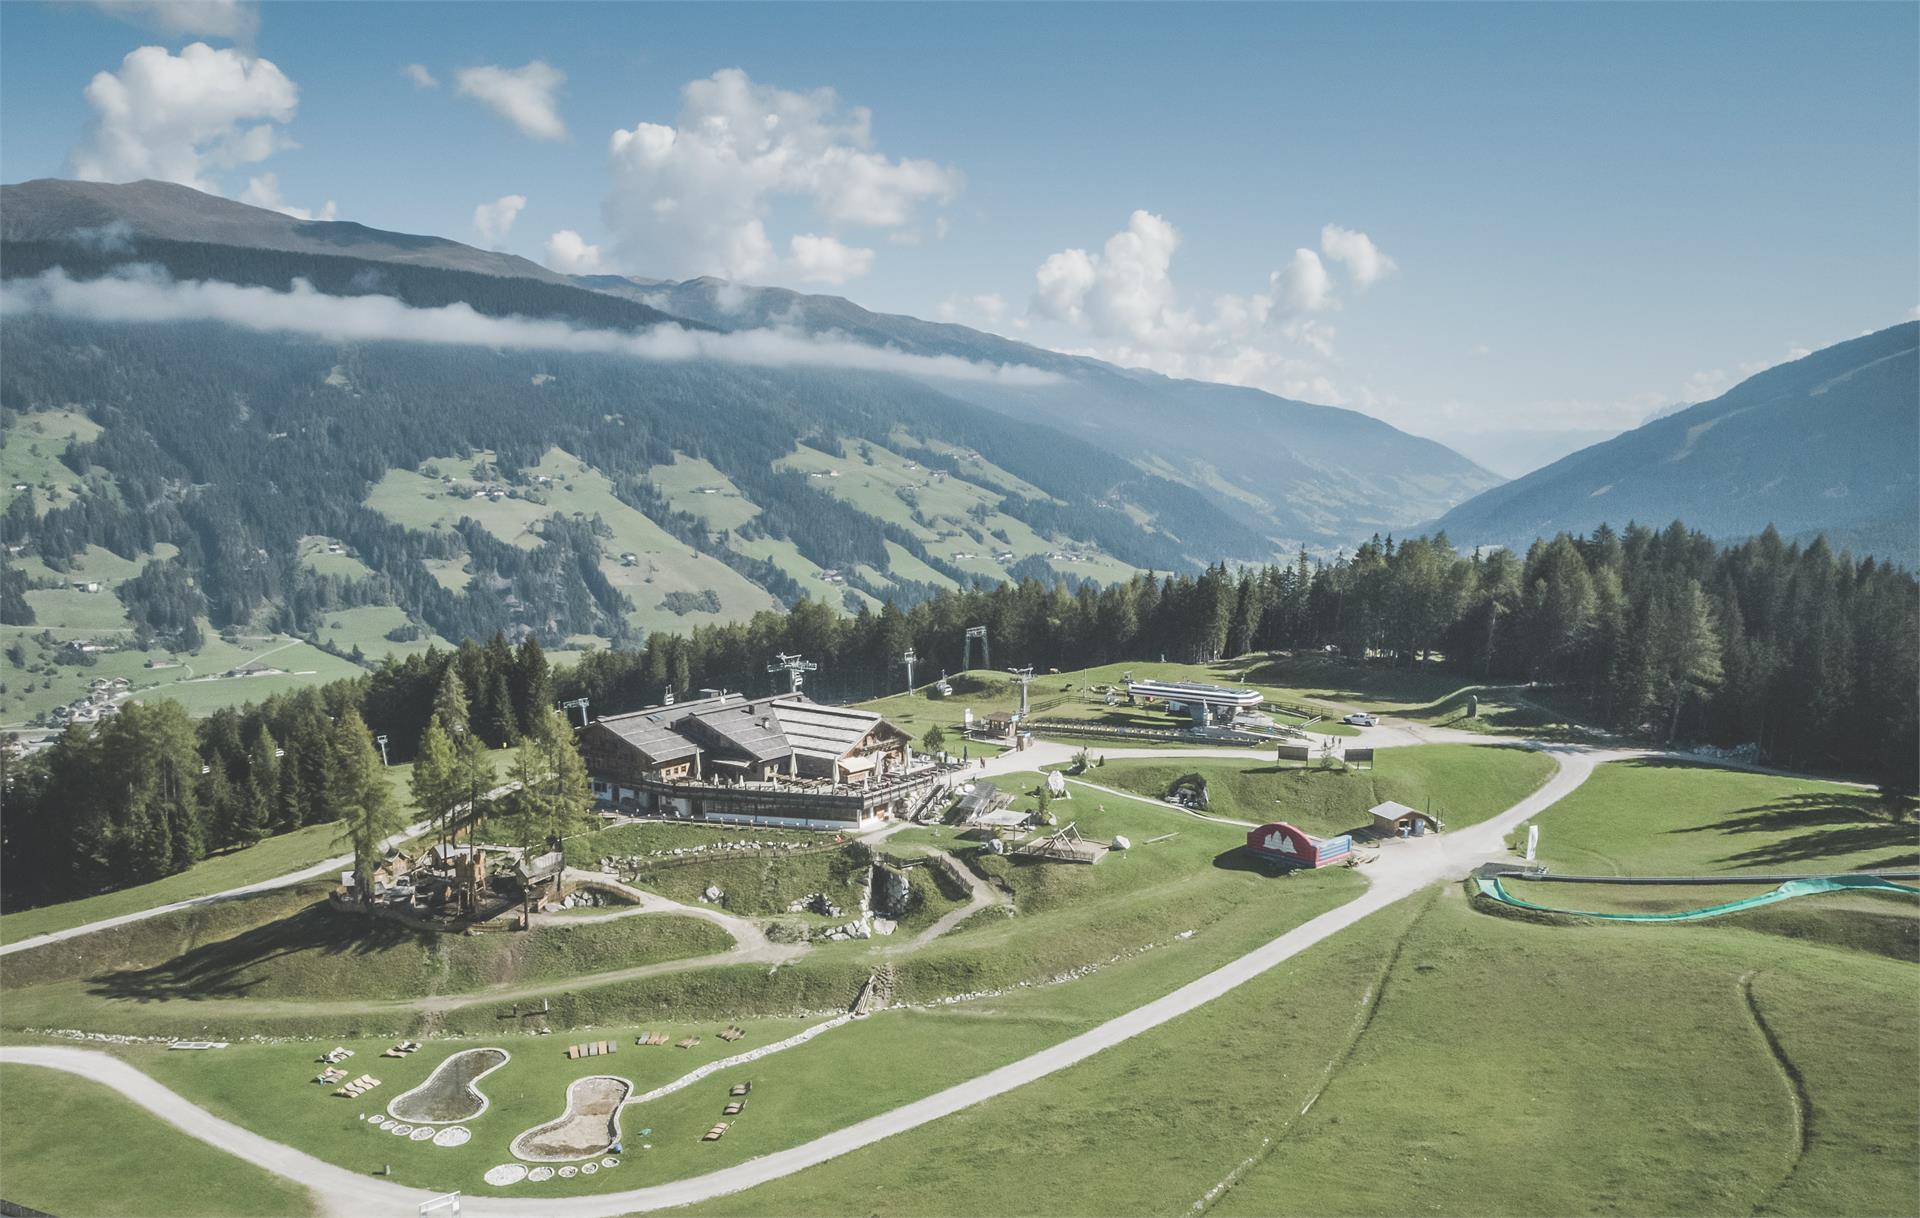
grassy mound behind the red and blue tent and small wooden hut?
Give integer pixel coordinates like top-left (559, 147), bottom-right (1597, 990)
top-left (1081, 743), bottom-right (1553, 836)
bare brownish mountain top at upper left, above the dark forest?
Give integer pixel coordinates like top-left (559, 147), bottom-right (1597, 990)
top-left (0, 179), bottom-right (566, 282)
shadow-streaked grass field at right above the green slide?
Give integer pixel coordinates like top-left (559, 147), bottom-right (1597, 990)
top-left (1538, 761), bottom-right (1920, 876)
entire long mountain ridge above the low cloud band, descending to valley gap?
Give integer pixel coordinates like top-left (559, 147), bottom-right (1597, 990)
top-left (0, 179), bottom-right (1500, 553)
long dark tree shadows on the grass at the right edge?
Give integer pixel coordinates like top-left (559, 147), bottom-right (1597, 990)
top-left (1668, 792), bottom-right (1920, 868)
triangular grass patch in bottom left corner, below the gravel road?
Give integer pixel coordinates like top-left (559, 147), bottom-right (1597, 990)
top-left (0, 1064), bottom-right (317, 1218)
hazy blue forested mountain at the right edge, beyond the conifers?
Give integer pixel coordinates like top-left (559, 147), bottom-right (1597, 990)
top-left (1434, 323), bottom-right (1920, 567)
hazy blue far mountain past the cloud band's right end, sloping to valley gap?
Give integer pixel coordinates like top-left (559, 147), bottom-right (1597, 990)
top-left (578, 275), bottom-right (1500, 549)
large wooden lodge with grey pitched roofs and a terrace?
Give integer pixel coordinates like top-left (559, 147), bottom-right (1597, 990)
top-left (580, 694), bottom-right (947, 830)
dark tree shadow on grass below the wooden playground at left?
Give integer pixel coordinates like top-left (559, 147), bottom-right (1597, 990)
top-left (86, 901), bottom-right (438, 1003)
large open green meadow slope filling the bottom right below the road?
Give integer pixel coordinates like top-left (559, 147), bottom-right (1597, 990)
top-left (695, 888), bottom-right (1920, 1216)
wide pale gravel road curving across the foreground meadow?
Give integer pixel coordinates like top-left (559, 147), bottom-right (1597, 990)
top-left (0, 738), bottom-right (1638, 1218)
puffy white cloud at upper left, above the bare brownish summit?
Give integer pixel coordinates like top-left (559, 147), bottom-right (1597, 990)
top-left (71, 42), bottom-right (300, 194)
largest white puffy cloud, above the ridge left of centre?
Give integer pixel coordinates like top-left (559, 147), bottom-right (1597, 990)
top-left (605, 69), bottom-right (960, 279)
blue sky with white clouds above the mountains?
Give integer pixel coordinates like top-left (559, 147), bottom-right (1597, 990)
top-left (0, 0), bottom-right (1920, 473)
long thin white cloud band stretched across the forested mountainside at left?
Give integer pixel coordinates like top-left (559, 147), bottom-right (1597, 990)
top-left (0, 267), bottom-right (1058, 384)
